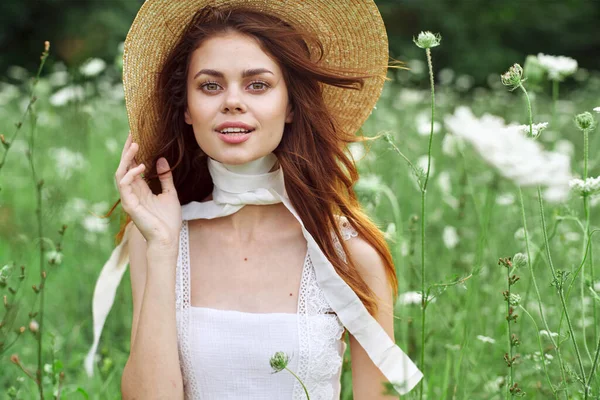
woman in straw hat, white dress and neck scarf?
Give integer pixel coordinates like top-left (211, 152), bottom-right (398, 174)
top-left (86, 0), bottom-right (422, 400)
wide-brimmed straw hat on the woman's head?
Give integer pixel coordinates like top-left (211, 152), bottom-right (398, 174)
top-left (123, 0), bottom-right (388, 166)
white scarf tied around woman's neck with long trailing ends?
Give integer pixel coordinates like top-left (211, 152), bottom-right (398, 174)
top-left (85, 153), bottom-right (423, 395)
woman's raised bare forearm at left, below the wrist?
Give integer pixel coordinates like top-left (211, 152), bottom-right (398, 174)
top-left (121, 225), bottom-right (183, 400)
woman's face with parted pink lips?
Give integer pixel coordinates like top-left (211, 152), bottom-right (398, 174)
top-left (185, 33), bottom-right (293, 165)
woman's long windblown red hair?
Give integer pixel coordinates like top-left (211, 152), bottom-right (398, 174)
top-left (105, 6), bottom-right (398, 316)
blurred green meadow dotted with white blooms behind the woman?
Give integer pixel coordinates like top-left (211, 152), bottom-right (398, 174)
top-left (0, 39), bottom-right (600, 400)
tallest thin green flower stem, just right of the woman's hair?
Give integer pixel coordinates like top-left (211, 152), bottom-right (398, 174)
top-left (419, 48), bottom-right (435, 400)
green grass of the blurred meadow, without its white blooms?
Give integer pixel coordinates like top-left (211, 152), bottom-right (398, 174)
top-left (0, 58), bottom-right (600, 399)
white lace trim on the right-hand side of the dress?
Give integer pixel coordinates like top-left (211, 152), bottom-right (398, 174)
top-left (292, 216), bottom-right (358, 400)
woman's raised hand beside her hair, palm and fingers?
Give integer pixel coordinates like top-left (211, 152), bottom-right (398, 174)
top-left (115, 134), bottom-right (181, 249)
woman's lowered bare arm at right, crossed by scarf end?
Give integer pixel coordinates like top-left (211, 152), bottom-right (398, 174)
top-left (346, 236), bottom-right (406, 400)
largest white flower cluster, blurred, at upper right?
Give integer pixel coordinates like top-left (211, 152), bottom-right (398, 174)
top-left (444, 106), bottom-right (572, 202)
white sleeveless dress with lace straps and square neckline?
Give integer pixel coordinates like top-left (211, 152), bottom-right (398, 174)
top-left (176, 217), bottom-right (358, 400)
